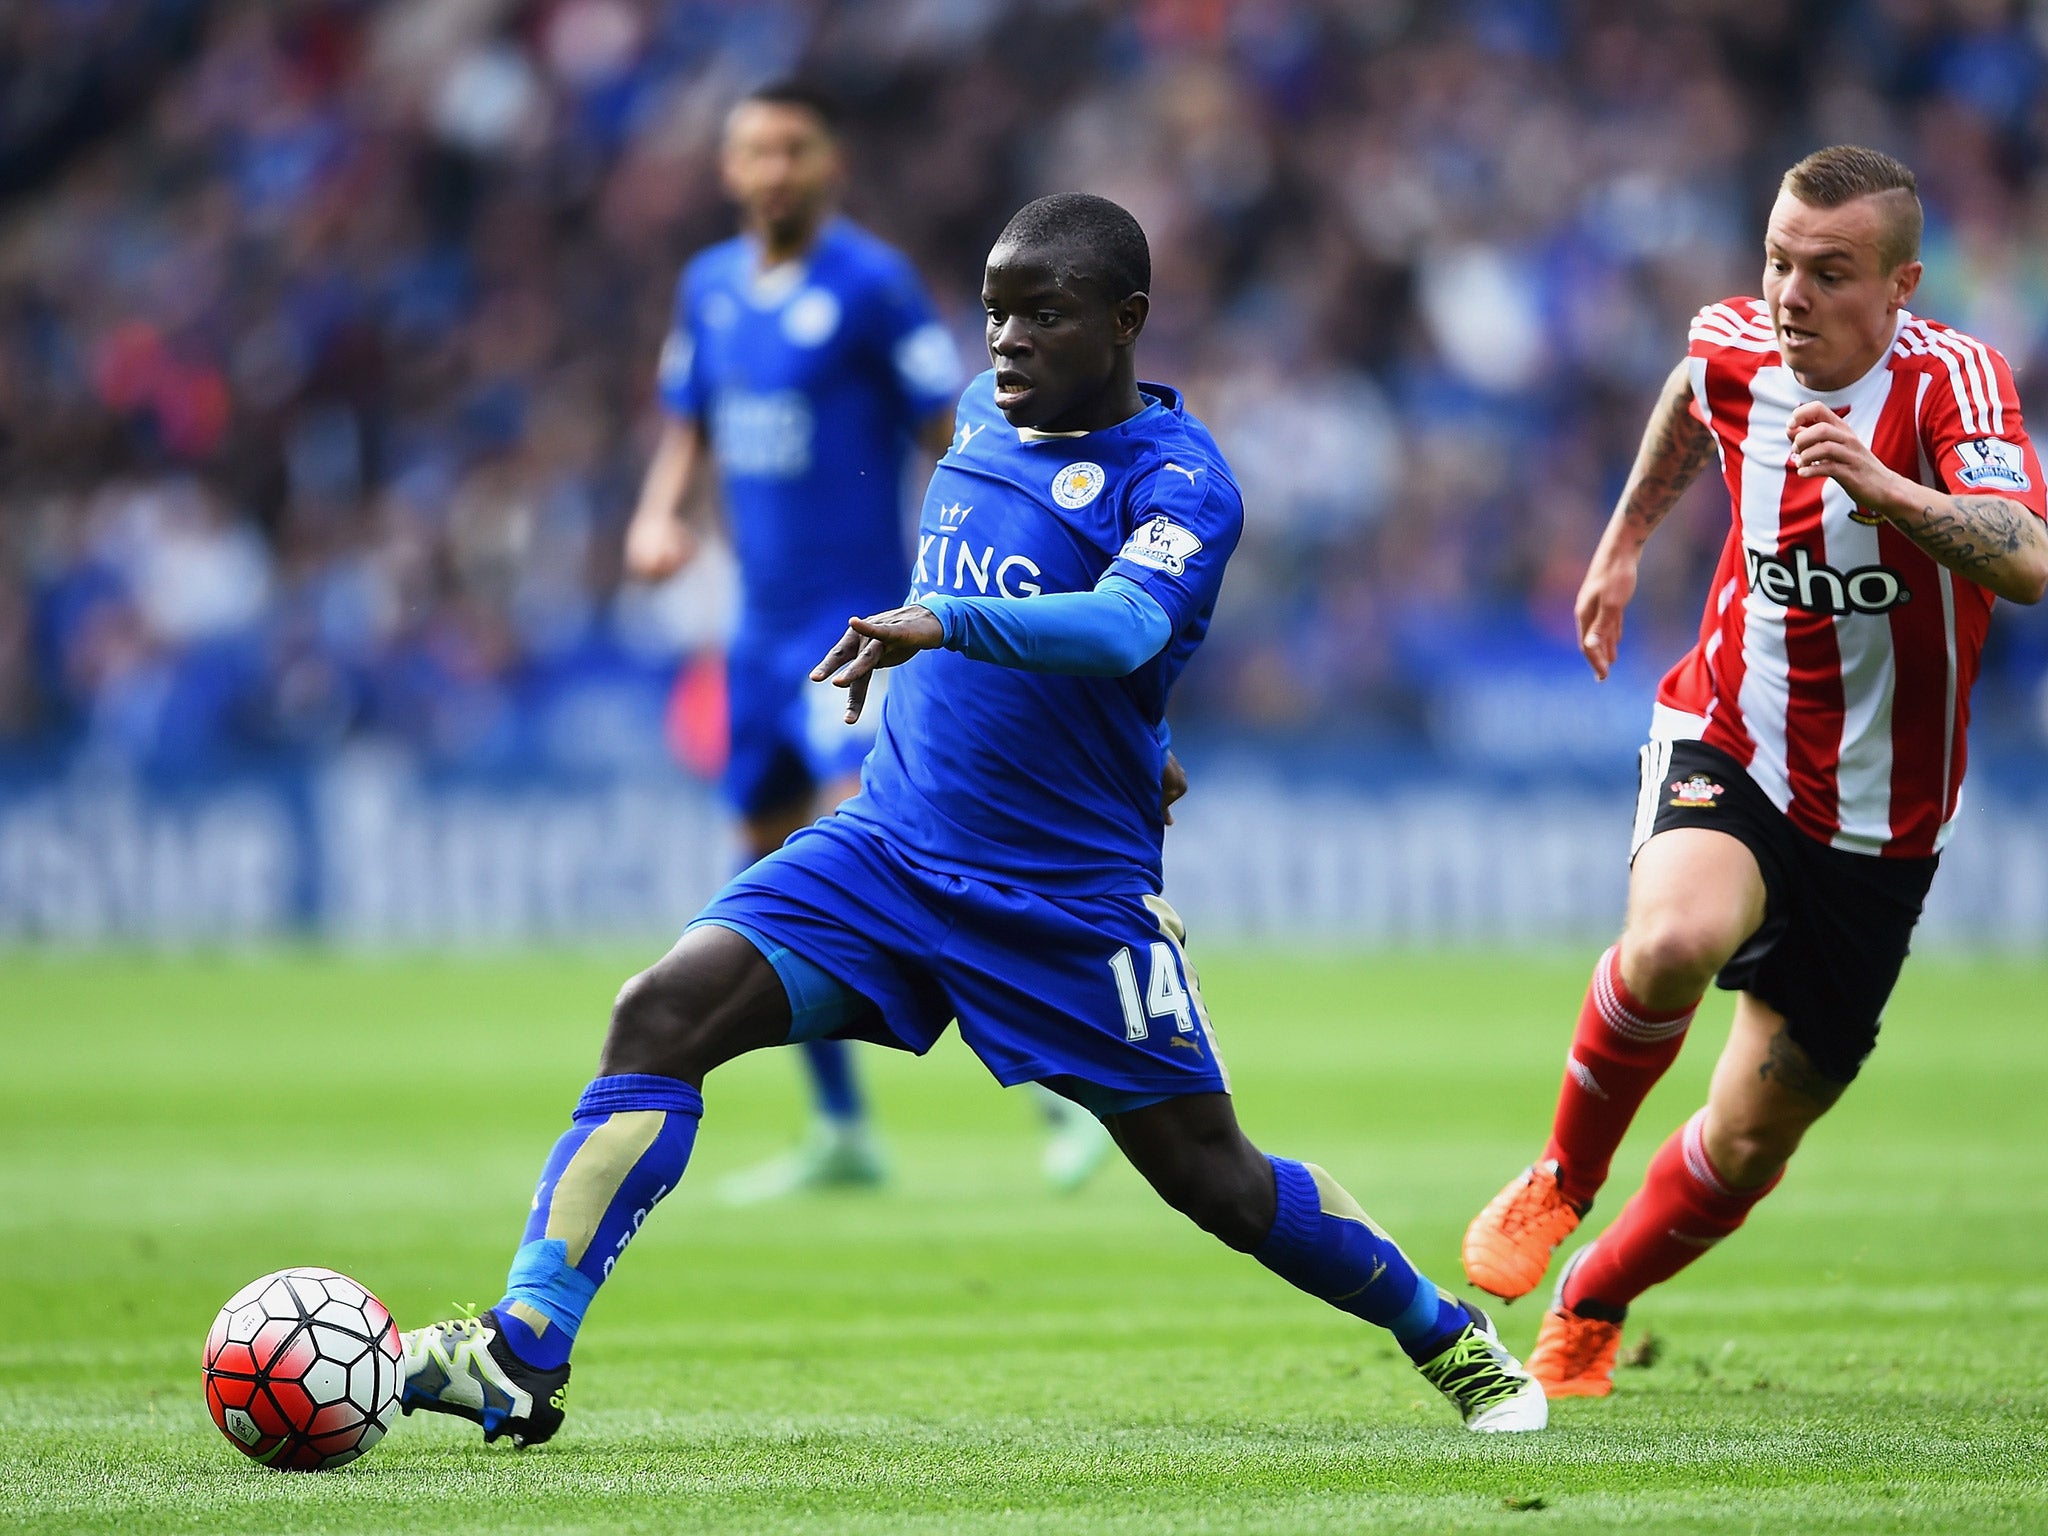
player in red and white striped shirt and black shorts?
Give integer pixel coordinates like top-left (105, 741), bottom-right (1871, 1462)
top-left (1464, 147), bottom-right (2048, 1397)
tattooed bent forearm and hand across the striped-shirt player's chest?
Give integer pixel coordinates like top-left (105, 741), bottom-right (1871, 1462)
top-left (1786, 401), bottom-right (2048, 602)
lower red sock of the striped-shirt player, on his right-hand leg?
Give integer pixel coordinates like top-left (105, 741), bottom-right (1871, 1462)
top-left (1559, 1110), bottom-right (1784, 1307)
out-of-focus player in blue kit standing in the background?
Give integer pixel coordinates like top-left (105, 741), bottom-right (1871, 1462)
top-left (627, 82), bottom-right (1110, 1204)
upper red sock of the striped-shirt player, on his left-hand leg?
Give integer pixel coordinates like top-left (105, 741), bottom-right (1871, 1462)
top-left (1542, 944), bottom-right (1700, 1206)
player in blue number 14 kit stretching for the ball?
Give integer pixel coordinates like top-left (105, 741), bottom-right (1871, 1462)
top-left (403, 195), bottom-right (1546, 1444)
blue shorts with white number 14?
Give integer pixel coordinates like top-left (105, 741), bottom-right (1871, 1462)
top-left (698, 815), bottom-right (1231, 1114)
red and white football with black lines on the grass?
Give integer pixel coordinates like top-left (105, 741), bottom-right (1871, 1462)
top-left (205, 1268), bottom-right (399, 1473)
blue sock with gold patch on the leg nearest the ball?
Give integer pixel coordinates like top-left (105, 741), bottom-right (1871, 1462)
top-left (494, 1073), bottom-right (705, 1370)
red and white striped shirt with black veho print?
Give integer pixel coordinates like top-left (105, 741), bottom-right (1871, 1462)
top-left (1651, 299), bottom-right (2048, 858)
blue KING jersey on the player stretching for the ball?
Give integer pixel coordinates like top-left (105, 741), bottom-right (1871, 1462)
top-left (842, 373), bottom-right (1243, 893)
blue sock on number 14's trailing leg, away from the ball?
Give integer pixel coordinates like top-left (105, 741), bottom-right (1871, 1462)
top-left (1251, 1157), bottom-right (1473, 1364)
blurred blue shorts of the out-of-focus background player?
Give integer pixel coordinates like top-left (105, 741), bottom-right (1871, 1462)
top-left (723, 621), bottom-right (887, 815)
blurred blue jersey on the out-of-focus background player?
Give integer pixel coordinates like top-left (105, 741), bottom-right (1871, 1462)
top-left (659, 219), bottom-right (961, 631)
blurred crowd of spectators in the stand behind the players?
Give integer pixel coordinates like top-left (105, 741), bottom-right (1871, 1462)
top-left (0, 0), bottom-right (2048, 768)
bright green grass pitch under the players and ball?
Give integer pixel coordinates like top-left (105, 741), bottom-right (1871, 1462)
top-left (0, 954), bottom-right (2048, 1534)
